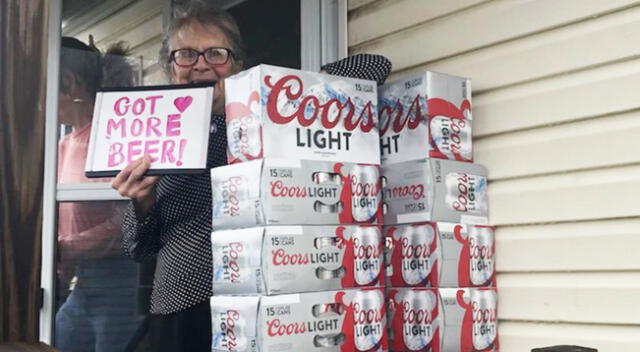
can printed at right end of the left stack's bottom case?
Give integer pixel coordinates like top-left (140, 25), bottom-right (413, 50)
top-left (351, 290), bottom-right (386, 351)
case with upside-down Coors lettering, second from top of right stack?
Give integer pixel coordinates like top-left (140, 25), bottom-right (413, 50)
top-left (382, 159), bottom-right (489, 225)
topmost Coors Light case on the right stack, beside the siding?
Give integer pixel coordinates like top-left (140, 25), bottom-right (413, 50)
top-left (378, 71), bottom-right (473, 165)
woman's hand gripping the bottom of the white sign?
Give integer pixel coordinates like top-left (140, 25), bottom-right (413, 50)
top-left (111, 155), bottom-right (160, 219)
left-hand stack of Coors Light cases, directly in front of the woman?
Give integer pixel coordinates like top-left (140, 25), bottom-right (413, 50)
top-left (211, 65), bottom-right (388, 352)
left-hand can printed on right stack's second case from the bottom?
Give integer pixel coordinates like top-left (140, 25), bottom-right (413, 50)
top-left (398, 224), bottom-right (439, 285)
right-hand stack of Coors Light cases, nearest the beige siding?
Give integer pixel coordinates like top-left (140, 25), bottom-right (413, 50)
top-left (378, 72), bottom-right (499, 352)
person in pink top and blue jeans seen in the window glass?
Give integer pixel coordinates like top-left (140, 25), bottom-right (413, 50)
top-left (54, 37), bottom-right (142, 352)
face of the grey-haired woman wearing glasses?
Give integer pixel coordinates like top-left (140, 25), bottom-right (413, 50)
top-left (169, 23), bottom-right (241, 114)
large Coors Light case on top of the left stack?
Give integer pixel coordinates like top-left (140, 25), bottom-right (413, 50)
top-left (225, 65), bottom-right (380, 165)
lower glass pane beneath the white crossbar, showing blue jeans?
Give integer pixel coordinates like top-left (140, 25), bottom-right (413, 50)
top-left (54, 201), bottom-right (153, 352)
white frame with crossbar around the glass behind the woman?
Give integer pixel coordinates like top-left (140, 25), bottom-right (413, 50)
top-left (40, 0), bottom-right (347, 344)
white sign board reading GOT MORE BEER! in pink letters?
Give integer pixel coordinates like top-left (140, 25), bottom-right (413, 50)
top-left (85, 85), bottom-right (213, 177)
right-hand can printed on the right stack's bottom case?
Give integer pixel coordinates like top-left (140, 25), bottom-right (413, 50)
top-left (471, 289), bottom-right (498, 351)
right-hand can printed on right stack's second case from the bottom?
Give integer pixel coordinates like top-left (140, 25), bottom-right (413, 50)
top-left (469, 226), bottom-right (495, 286)
